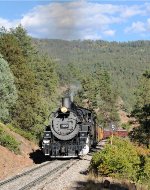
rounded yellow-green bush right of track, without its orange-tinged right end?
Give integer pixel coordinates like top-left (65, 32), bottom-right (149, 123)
top-left (91, 138), bottom-right (140, 181)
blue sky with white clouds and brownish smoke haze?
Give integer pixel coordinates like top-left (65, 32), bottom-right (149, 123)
top-left (0, 0), bottom-right (150, 42)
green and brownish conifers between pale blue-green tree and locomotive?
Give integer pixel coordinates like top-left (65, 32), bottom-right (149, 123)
top-left (0, 26), bottom-right (58, 136)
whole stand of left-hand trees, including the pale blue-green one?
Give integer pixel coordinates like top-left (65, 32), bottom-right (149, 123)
top-left (0, 26), bottom-right (59, 139)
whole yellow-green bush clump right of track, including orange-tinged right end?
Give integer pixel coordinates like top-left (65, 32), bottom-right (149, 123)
top-left (90, 137), bottom-right (150, 187)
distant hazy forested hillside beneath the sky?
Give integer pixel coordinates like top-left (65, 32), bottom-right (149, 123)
top-left (33, 39), bottom-right (150, 111)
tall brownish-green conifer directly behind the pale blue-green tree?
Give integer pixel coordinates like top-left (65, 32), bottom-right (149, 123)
top-left (0, 28), bottom-right (45, 130)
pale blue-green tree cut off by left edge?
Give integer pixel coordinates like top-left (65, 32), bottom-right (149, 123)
top-left (0, 55), bottom-right (17, 122)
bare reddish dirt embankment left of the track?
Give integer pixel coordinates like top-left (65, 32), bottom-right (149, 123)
top-left (0, 125), bottom-right (39, 180)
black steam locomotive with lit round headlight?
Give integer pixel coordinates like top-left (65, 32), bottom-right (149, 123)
top-left (42, 97), bottom-right (97, 157)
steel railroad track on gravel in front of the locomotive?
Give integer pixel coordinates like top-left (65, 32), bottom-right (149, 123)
top-left (0, 160), bottom-right (78, 190)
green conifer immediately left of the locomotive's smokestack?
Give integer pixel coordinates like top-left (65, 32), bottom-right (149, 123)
top-left (32, 55), bottom-right (59, 120)
